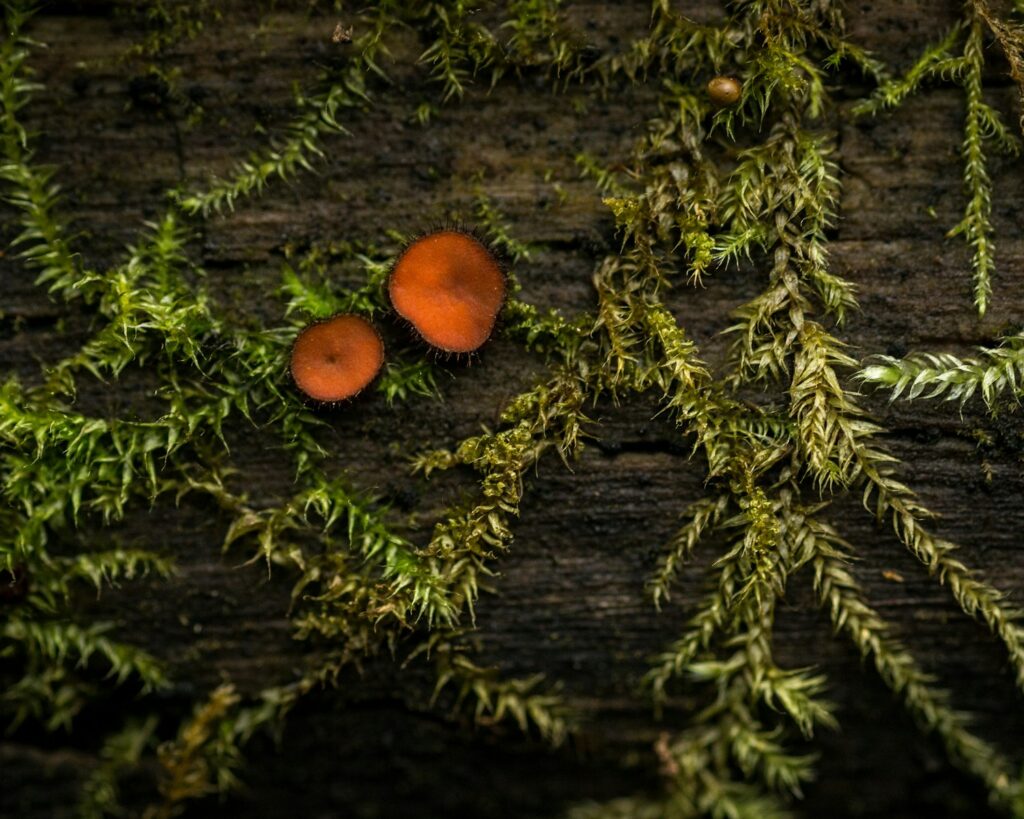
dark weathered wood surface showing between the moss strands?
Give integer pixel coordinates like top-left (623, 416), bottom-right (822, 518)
top-left (0, 0), bottom-right (1024, 819)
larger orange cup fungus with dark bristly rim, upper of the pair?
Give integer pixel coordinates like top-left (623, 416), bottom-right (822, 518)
top-left (388, 229), bottom-right (505, 352)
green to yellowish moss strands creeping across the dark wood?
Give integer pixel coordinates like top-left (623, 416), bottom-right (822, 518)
top-left (0, 0), bottom-right (1024, 819)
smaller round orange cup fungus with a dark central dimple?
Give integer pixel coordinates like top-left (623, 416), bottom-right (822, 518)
top-left (291, 313), bottom-right (384, 403)
